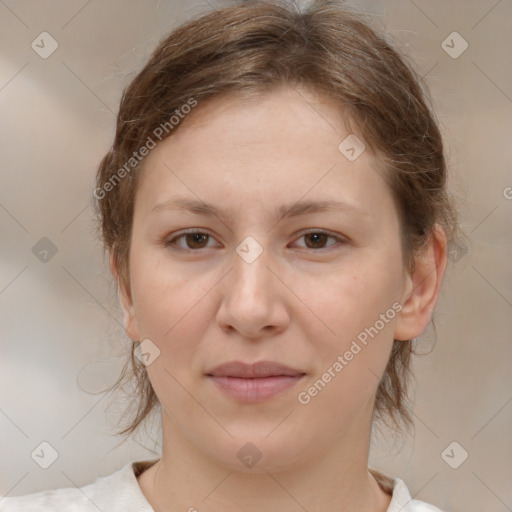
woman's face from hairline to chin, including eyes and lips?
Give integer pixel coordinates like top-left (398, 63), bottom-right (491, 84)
top-left (116, 84), bottom-right (424, 470)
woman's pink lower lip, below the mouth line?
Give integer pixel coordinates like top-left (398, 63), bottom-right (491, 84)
top-left (209, 374), bottom-right (304, 402)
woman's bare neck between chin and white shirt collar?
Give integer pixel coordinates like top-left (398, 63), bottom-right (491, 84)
top-left (139, 410), bottom-right (391, 512)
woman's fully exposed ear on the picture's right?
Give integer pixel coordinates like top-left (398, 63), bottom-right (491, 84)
top-left (394, 224), bottom-right (447, 341)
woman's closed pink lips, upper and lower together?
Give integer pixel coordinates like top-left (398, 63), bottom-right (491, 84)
top-left (206, 361), bottom-right (305, 402)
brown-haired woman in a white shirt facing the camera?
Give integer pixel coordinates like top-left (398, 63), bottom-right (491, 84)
top-left (2, 1), bottom-right (464, 512)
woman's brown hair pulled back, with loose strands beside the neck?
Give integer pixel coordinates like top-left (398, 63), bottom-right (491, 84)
top-left (94, 0), bottom-right (461, 440)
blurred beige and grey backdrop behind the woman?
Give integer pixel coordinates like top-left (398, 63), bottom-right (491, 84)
top-left (0, 0), bottom-right (512, 512)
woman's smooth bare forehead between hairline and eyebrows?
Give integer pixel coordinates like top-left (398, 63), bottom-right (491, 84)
top-left (137, 87), bottom-right (392, 224)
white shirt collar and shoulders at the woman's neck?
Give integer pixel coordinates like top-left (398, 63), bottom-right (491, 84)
top-left (0, 461), bottom-right (442, 512)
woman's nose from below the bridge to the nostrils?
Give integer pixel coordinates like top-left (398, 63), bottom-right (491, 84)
top-left (217, 244), bottom-right (292, 339)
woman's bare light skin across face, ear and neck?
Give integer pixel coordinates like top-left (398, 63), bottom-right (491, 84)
top-left (111, 87), bottom-right (446, 512)
